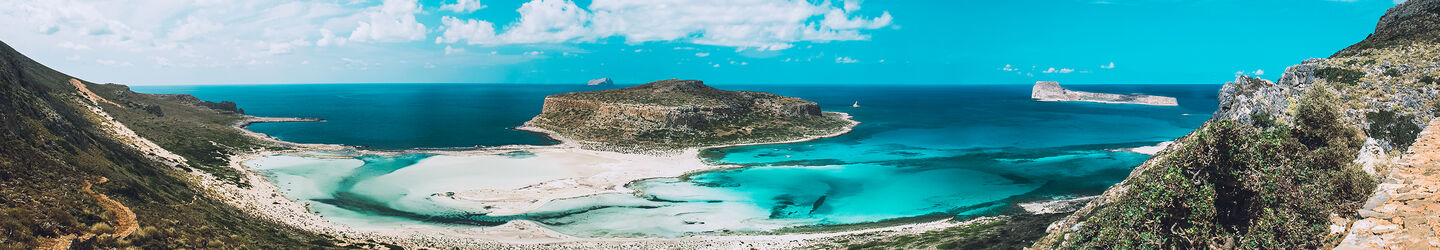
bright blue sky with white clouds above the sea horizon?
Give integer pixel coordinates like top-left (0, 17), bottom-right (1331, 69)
top-left (0, 0), bottom-right (1400, 85)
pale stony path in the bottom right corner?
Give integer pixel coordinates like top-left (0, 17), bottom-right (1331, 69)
top-left (1335, 119), bottom-right (1440, 249)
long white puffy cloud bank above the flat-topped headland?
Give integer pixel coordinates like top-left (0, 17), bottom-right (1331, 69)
top-left (438, 0), bottom-right (893, 50)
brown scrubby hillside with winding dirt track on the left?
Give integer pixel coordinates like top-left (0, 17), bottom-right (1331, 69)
top-left (0, 43), bottom-right (328, 249)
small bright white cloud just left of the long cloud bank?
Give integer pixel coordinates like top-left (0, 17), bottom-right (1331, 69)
top-left (350, 0), bottom-right (425, 42)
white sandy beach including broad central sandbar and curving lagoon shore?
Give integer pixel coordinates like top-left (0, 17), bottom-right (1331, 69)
top-left (174, 114), bottom-right (1008, 249)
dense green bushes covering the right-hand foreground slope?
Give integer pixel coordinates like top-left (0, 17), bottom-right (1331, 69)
top-left (1064, 88), bottom-right (1375, 249)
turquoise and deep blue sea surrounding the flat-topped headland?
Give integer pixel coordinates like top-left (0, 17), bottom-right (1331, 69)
top-left (135, 85), bottom-right (1220, 237)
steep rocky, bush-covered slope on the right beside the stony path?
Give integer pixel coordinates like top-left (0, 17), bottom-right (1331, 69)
top-left (1034, 0), bottom-right (1440, 249)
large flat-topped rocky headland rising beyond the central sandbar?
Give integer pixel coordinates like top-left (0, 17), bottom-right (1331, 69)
top-left (526, 79), bottom-right (851, 152)
